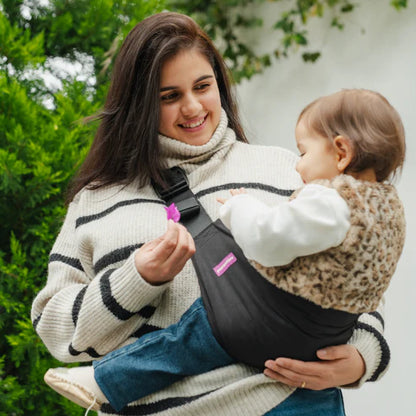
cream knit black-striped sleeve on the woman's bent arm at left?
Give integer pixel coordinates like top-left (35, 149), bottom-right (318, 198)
top-left (32, 193), bottom-right (169, 362)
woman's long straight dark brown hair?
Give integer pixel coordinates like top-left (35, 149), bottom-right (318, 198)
top-left (67, 12), bottom-right (247, 203)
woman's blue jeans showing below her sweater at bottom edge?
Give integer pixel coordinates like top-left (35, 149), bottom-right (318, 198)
top-left (264, 388), bottom-right (345, 416)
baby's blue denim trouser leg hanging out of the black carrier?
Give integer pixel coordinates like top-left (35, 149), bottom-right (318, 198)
top-left (93, 298), bottom-right (234, 410)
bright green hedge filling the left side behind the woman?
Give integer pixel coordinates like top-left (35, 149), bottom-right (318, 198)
top-left (0, 0), bottom-right (164, 416)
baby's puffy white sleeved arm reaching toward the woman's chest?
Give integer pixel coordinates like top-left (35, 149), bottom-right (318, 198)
top-left (220, 184), bottom-right (350, 267)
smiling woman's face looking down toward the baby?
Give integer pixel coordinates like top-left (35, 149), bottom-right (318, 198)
top-left (159, 49), bottom-right (221, 146)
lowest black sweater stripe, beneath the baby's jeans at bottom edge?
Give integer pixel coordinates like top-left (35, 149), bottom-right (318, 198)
top-left (100, 389), bottom-right (216, 416)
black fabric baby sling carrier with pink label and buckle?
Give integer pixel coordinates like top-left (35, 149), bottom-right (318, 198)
top-left (154, 168), bottom-right (358, 369)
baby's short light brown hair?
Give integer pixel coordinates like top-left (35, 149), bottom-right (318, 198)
top-left (297, 89), bottom-right (406, 182)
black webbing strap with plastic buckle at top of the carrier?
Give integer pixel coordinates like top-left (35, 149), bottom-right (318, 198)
top-left (153, 166), bottom-right (212, 237)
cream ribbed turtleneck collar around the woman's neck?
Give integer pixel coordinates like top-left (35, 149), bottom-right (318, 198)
top-left (159, 109), bottom-right (236, 173)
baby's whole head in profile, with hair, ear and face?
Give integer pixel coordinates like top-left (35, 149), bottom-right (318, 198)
top-left (296, 89), bottom-right (406, 182)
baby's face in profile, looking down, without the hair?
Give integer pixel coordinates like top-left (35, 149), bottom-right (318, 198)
top-left (295, 120), bottom-right (340, 183)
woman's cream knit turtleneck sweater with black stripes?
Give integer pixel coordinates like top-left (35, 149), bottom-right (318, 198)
top-left (32, 112), bottom-right (389, 416)
